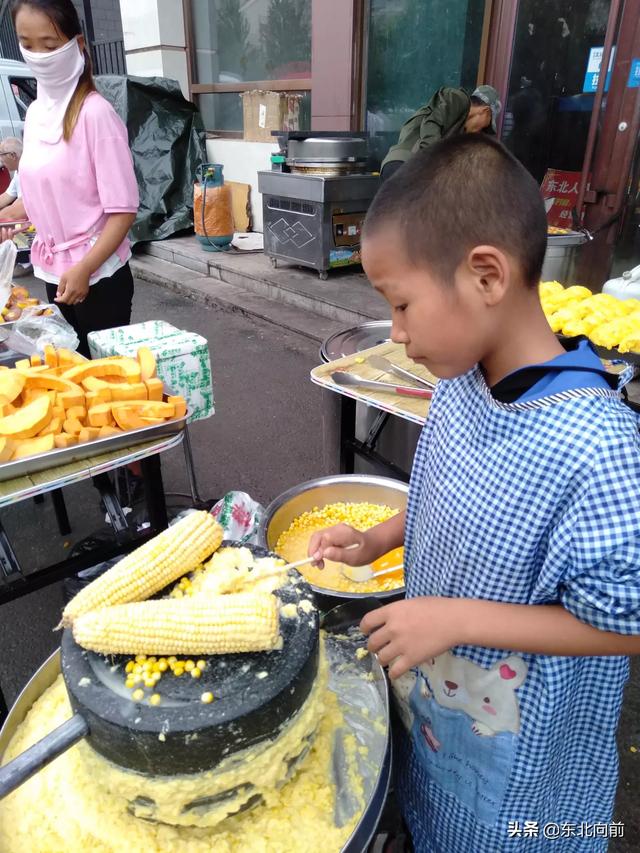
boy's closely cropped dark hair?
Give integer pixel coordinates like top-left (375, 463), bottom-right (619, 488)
top-left (364, 133), bottom-right (547, 287)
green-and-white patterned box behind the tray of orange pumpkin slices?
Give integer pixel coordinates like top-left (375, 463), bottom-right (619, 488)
top-left (87, 320), bottom-right (215, 423)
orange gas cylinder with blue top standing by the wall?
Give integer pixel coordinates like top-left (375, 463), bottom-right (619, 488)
top-left (193, 163), bottom-right (233, 252)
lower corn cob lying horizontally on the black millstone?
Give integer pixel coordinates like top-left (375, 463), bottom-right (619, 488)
top-left (73, 592), bottom-right (279, 655)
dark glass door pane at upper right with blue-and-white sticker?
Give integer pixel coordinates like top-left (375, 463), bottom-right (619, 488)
top-left (502, 0), bottom-right (611, 186)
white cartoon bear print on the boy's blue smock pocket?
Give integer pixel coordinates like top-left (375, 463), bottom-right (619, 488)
top-left (420, 651), bottom-right (528, 737)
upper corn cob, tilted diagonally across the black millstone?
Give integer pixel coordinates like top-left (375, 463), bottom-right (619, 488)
top-left (61, 512), bottom-right (223, 628)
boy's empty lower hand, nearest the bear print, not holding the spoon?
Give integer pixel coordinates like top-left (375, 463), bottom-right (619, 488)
top-left (360, 597), bottom-right (461, 678)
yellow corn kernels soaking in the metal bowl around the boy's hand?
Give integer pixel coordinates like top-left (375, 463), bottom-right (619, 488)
top-left (275, 502), bottom-right (404, 592)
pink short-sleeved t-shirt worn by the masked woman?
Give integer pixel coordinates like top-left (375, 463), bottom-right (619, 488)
top-left (20, 92), bottom-right (139, 277)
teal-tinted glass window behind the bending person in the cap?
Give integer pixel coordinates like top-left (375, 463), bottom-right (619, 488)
top-left (366, 0), bottom-right (484, 166)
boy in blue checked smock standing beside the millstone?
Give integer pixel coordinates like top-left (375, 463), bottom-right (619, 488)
top-left (309, 135), bottom-right (640, 853)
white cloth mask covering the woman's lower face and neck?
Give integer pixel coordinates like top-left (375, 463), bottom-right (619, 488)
top-left (20, 36), bottom-right (84, 143)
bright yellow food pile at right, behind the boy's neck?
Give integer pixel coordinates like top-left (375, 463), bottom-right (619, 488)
top-left (540, 281), bottom-right (640, 353)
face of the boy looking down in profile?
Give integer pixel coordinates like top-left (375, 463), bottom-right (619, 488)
top-left (362, 225), bottom-right (493, 379)
